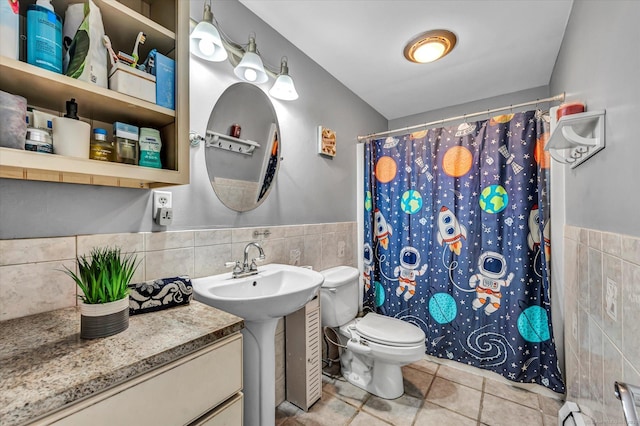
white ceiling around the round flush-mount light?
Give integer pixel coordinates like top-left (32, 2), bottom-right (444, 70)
top-left (240, 0), bottom-right (572, 120)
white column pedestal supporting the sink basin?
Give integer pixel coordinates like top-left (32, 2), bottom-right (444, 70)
top-left (242, 318), bottom-right (280, 426)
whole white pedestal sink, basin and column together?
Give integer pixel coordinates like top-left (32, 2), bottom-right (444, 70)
top-left (192, 263), bottom-right (324, 426)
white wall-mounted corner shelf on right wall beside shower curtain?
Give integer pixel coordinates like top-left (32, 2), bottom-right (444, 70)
top-left (544, 110), bottom-right (605, 168)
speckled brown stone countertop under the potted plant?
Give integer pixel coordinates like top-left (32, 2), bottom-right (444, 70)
top-left (0, 301), bottom-right (244, 426)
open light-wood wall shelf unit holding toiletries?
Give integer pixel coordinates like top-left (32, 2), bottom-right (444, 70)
top-left (0, 0), bottom-right (189, 188)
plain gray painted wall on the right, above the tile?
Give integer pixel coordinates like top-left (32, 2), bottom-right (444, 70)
top-left (550, 0), bottom-right (640, 236)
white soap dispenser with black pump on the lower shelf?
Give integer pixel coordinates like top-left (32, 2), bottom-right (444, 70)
top-left (53, 98), bottom-right (91, 158)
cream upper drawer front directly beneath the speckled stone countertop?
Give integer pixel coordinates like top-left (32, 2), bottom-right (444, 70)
top-left (36, 334), bottom-right (242, 426)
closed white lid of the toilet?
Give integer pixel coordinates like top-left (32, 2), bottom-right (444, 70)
top-left (356, 312), bottom-right (425, 346)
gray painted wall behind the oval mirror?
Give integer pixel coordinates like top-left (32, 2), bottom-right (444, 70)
top-left (0, 0), bottom-right (387, 239)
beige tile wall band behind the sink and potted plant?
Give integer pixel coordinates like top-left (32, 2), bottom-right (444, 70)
top-left (0, 222), bottom-right (357, 404)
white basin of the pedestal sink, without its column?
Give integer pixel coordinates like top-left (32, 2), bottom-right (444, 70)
top-left (192, 263), bottom-right (324, 321)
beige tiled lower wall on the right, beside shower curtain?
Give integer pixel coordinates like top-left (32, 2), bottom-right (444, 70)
top-left (564, 226), bottom-right (640, 424)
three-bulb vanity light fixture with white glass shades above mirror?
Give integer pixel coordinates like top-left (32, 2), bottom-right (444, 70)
top-left (190, 0), bottom-right (298, 101)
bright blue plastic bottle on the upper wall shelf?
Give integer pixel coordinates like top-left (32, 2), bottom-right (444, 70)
top-left (27, 0), bottom-right (62, 74)
